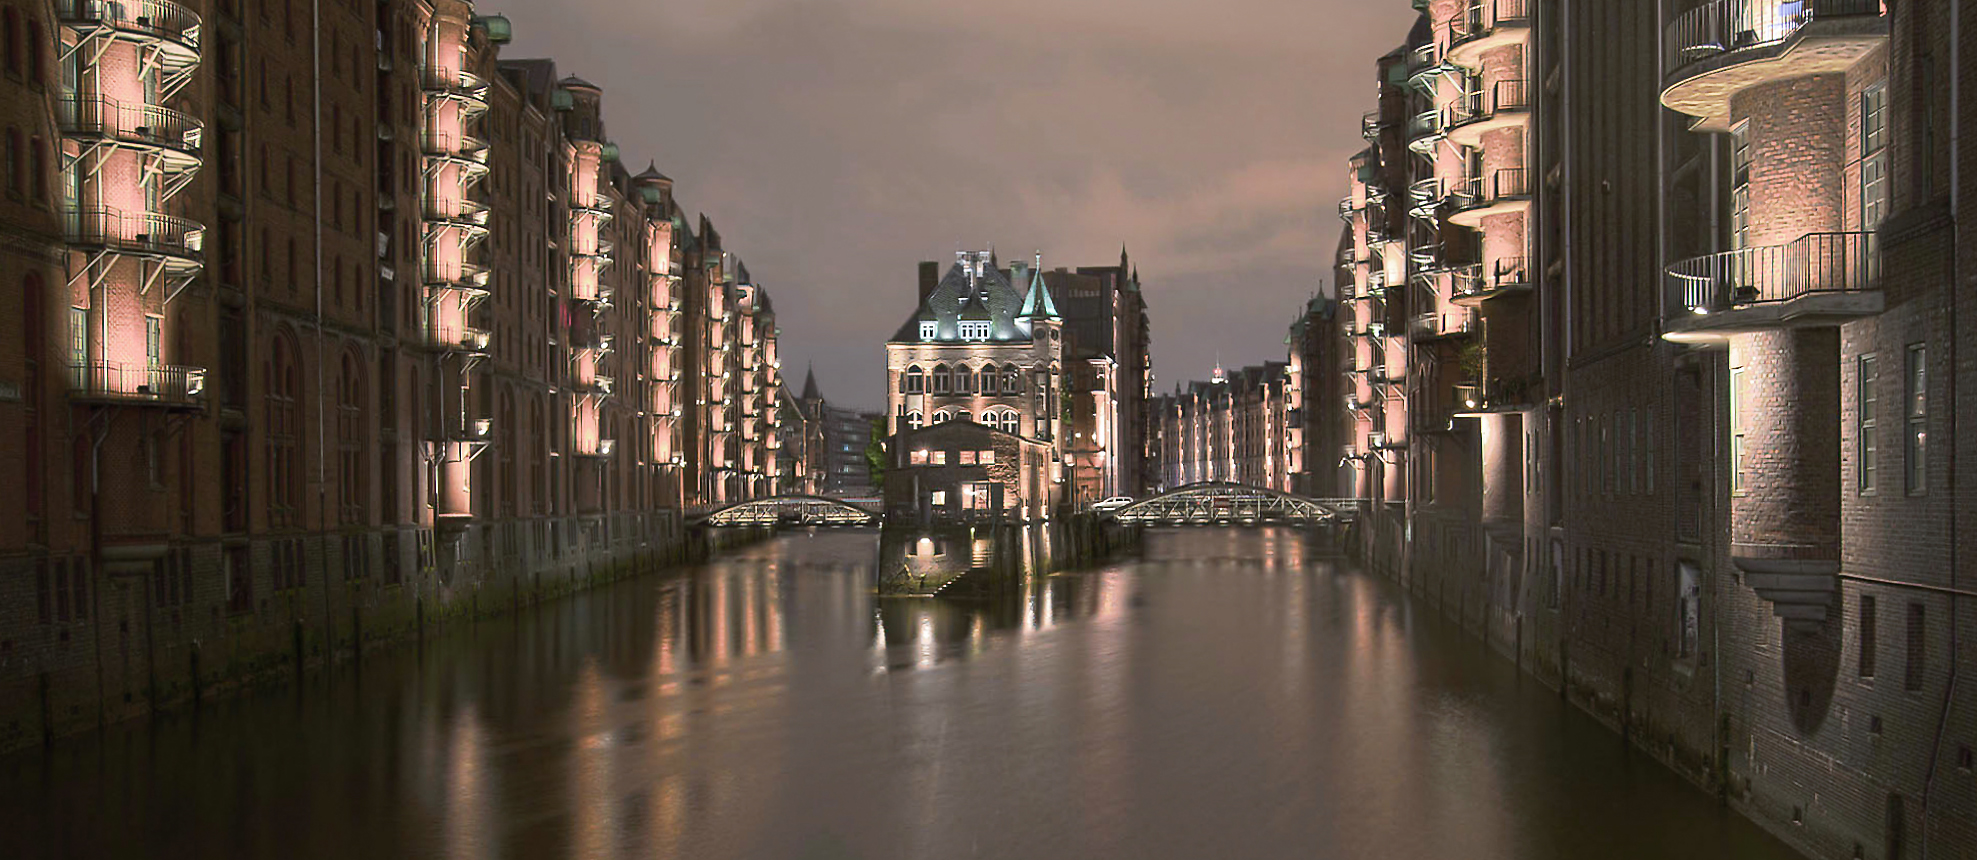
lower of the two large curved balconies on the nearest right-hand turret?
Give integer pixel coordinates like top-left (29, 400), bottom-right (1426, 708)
top-left (1663, 233), bottom-right (1886, 344)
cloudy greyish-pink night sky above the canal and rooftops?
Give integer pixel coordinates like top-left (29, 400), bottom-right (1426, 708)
top-left (498, 0), bottom-right (1414, 407)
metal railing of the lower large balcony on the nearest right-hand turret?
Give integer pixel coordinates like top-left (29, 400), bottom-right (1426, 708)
top-left (1665, 233), bottom-right (1880, 314)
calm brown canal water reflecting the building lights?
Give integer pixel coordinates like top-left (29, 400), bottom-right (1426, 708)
top-left (0, 530), bottom-right (1793, 858)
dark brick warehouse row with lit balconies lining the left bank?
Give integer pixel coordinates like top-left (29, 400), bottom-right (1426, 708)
top-left (0, 0), bottom-right (781, 745)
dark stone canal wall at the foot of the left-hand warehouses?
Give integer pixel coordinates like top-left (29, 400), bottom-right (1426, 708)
top-left (0, 512), bottom-right (773, 751)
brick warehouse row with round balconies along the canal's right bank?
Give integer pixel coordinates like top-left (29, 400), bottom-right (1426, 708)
top-left (1305, 0), bottom-right (1977, 858)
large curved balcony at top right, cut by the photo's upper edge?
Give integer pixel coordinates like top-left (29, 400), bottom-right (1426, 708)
top-left (1661, 0), bottom-right (1888, 132)
